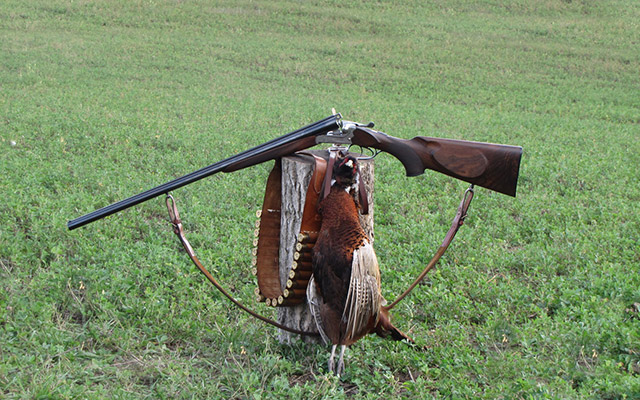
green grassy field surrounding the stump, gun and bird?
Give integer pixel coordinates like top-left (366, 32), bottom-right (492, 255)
top-left (0, 0), bottom-right (640, 399)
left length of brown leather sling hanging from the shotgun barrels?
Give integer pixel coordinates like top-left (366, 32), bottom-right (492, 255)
top-left (166, 195), bottom-right (320, 336)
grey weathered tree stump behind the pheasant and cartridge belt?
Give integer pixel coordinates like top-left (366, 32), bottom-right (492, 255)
top-left (278, 150), bottom-right (374, 344)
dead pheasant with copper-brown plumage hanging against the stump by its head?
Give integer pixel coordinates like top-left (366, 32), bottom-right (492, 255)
top-left (307, 156), bottom-right (413, 375)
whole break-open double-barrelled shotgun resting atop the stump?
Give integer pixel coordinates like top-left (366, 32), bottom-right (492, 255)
top-left (67, 114), bottom-right (522, 230)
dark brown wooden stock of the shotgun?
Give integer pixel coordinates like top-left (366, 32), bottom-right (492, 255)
top-left (352, 127), bottom-right (522, 197)
